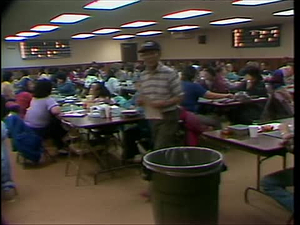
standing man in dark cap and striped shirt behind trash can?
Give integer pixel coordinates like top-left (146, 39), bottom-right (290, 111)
top-left (137, 41), bottom-right (183, 150)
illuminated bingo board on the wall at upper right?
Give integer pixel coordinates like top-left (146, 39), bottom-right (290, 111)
top-left (232, 25), bottom-right (280, 48)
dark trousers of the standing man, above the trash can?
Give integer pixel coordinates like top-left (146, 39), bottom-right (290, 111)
top-left (151, 109), bottom-right (179, 150)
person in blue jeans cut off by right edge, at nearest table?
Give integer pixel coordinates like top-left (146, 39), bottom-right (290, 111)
top-left (260, 133), bottom-right (294, 212)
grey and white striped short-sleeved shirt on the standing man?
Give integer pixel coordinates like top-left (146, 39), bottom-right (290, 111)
top-left (140, 62), bottom-right (183, 112)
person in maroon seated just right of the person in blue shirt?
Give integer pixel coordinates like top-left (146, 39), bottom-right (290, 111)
top-left (200, 67), bottom-right (229, 93)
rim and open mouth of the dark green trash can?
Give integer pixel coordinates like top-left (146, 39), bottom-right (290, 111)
top-left (143, 146), bottom-right (223, 177)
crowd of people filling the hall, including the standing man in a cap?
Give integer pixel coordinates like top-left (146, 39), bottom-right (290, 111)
top-left (1, 41), bottom-right (294, 216)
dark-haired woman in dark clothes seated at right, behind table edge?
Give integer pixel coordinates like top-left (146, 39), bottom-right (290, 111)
top-left (228, 66), bottom-right (268, 124)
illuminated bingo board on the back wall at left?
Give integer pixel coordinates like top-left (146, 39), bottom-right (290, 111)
top-left (20, 40), bottom-right (71, 60)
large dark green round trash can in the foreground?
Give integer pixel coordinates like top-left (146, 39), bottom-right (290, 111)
top-left (143, 147), bottom-right (223, 225)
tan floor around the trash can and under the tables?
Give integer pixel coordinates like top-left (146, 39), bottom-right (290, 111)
top-left (2, 143), bottom-right (293, 225)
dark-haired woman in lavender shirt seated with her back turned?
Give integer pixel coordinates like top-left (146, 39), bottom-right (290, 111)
top-left (24, 79), bottom-right (66, 153)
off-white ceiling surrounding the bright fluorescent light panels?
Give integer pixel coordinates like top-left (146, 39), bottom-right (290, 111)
top-left (1, 0), bottom-right (294, 40)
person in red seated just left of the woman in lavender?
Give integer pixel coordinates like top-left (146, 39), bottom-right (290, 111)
top-left (16, 77), bottom-right (34, 119)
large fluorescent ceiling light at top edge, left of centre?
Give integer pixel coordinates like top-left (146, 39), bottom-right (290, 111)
top-left (83, 0), bottom-right (140, 10)
